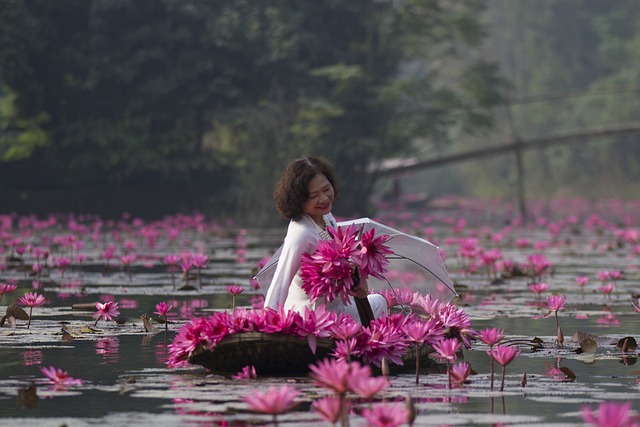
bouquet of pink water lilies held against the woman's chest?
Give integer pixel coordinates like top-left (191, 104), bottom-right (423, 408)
top-left (300, 225), bottom-right (393, 304)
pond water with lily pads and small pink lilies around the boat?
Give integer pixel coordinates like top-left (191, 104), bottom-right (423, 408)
top-left (0, 203), bottom-right (640, 426)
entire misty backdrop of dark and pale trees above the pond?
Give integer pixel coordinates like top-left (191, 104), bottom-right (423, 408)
top-left (0, 0), bottom-right (640, 224)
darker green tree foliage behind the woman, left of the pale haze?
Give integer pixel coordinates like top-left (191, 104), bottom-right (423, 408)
top-left (0, 0), bottom-right (504, 221)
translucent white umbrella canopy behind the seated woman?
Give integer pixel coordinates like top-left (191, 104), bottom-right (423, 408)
top-left (254, 218), bottom-right (457, 301)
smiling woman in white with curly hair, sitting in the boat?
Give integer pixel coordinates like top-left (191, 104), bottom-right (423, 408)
top-left (264, 157), bottom-right (387, 321)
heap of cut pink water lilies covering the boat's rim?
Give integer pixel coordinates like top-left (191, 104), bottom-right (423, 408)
top-left (168, 297), bottom-right (476, 367)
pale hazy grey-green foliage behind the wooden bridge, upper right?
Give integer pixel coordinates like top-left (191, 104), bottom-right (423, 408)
top-left (450, 0), bottom-right (640, 202)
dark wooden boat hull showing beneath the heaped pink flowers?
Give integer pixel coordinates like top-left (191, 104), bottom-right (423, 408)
top-left (188, 332), bottom-right (438, 376)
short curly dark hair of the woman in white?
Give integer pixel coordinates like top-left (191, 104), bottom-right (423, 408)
top-left (273, 157), bottom-right (338, 221)
